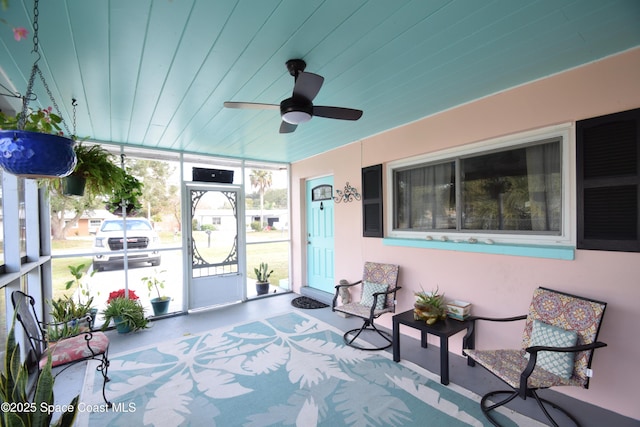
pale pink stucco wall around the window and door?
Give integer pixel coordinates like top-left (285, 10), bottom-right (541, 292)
top-left (291, 49), bottom-right (640, 419)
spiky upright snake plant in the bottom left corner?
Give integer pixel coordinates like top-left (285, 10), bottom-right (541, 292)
top-left (0, 316), bottom-right (80, 427)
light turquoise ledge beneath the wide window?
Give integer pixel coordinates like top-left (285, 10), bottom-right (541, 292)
top-left (382, 237), bottom-right (575, 261)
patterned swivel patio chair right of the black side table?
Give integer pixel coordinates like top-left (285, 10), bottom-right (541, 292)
top-left (464, 288), bottom-right (607, 426)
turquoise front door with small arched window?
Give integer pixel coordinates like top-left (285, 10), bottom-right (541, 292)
top-left (306, 176), bottom-right (336, 294)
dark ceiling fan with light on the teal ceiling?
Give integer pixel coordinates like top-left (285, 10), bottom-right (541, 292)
top-left (224, 59), bottom-right (362, 133)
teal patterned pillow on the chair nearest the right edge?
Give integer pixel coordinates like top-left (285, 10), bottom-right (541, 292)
top-left (525, 320), bottom-right (578, 379)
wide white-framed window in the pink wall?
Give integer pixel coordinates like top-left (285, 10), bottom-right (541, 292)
top-left (386, 125), bottom-right (575, 245)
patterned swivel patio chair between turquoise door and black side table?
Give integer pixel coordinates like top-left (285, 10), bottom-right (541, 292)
top-left (331, 262), bottom-right (401, 350)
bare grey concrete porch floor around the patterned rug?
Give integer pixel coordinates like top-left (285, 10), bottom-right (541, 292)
top-left (55, 292), bottom-right (639, 427)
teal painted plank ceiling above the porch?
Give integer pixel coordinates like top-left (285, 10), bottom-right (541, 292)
top-left (0, 0), bottom-right (640, 162)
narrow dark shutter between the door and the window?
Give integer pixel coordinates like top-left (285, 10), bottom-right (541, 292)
top-left (362, 165), bottom-right (384, 237)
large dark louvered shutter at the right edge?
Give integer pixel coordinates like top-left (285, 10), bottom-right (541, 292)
top-left (576, 108), bottom-right (640, 252)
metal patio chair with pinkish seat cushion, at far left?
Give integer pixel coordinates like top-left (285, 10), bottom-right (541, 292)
top-left (11, 291), bottom-right (111, 407)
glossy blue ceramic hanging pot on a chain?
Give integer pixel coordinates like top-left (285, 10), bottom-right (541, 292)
top-left (0, 130), bottom-right (77, 178)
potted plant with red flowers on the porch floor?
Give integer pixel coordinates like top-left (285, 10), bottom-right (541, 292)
top-left (102, 289), bottom-right (148, 333)
